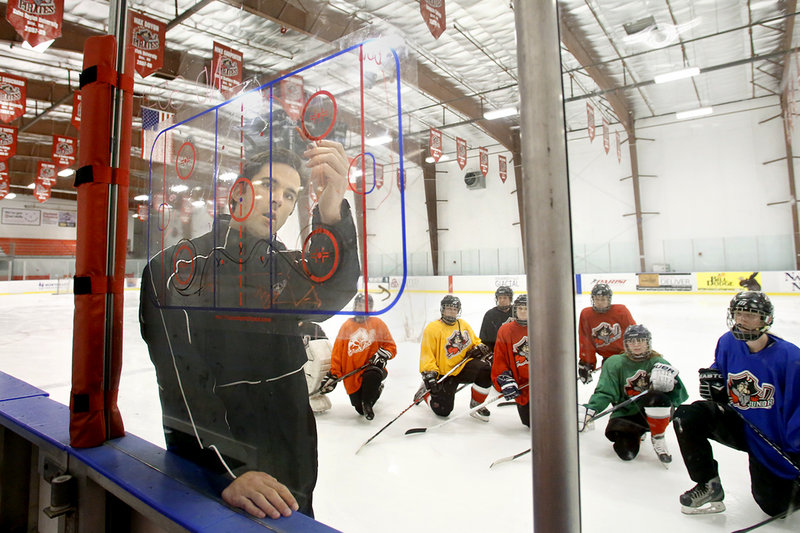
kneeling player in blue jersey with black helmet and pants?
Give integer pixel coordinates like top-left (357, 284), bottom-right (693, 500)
top-left (673, 291), bottom-right (800, 517)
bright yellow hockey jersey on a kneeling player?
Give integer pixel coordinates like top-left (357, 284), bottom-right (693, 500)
top-left (419, 319), bottom-right (481, 376)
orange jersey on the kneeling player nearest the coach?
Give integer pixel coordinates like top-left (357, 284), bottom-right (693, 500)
top-left (331, 316), bottom-right (397, 394)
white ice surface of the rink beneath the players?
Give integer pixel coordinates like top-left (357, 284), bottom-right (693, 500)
top-left (0, 291), bottom-right (800, 533)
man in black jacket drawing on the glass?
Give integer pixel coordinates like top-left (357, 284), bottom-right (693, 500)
top-left (140, 140), bottom-right (359, 518)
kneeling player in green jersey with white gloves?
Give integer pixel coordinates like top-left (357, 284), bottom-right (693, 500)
top-left (578, 324), bottom-right (689, 466)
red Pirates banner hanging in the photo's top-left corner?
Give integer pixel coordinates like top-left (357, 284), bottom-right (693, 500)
top-left (6, 0), bottom-right (64, 46)
